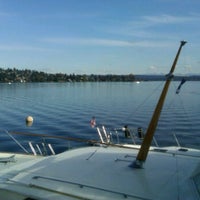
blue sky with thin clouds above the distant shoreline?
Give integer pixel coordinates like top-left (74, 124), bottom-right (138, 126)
top-left (0, 0), bottom-right (200, 74)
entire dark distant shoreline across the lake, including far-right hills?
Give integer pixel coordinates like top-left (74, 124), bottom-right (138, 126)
top-left (0, 68), bottom-right (200, 83)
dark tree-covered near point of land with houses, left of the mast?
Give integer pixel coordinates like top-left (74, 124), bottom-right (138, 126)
top-left (0, 68), bottom-right (135, 83)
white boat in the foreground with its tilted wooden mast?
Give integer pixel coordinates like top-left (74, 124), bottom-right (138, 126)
top-left (0, 41), bottom-right (200, 200)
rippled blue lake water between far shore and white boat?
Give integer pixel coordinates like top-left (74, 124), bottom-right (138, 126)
top-left (0, 82), bottom-right (200, 152)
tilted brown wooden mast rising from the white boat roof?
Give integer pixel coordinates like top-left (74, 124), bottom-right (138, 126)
top-left (133, 41), bottom-right (186, 168)
